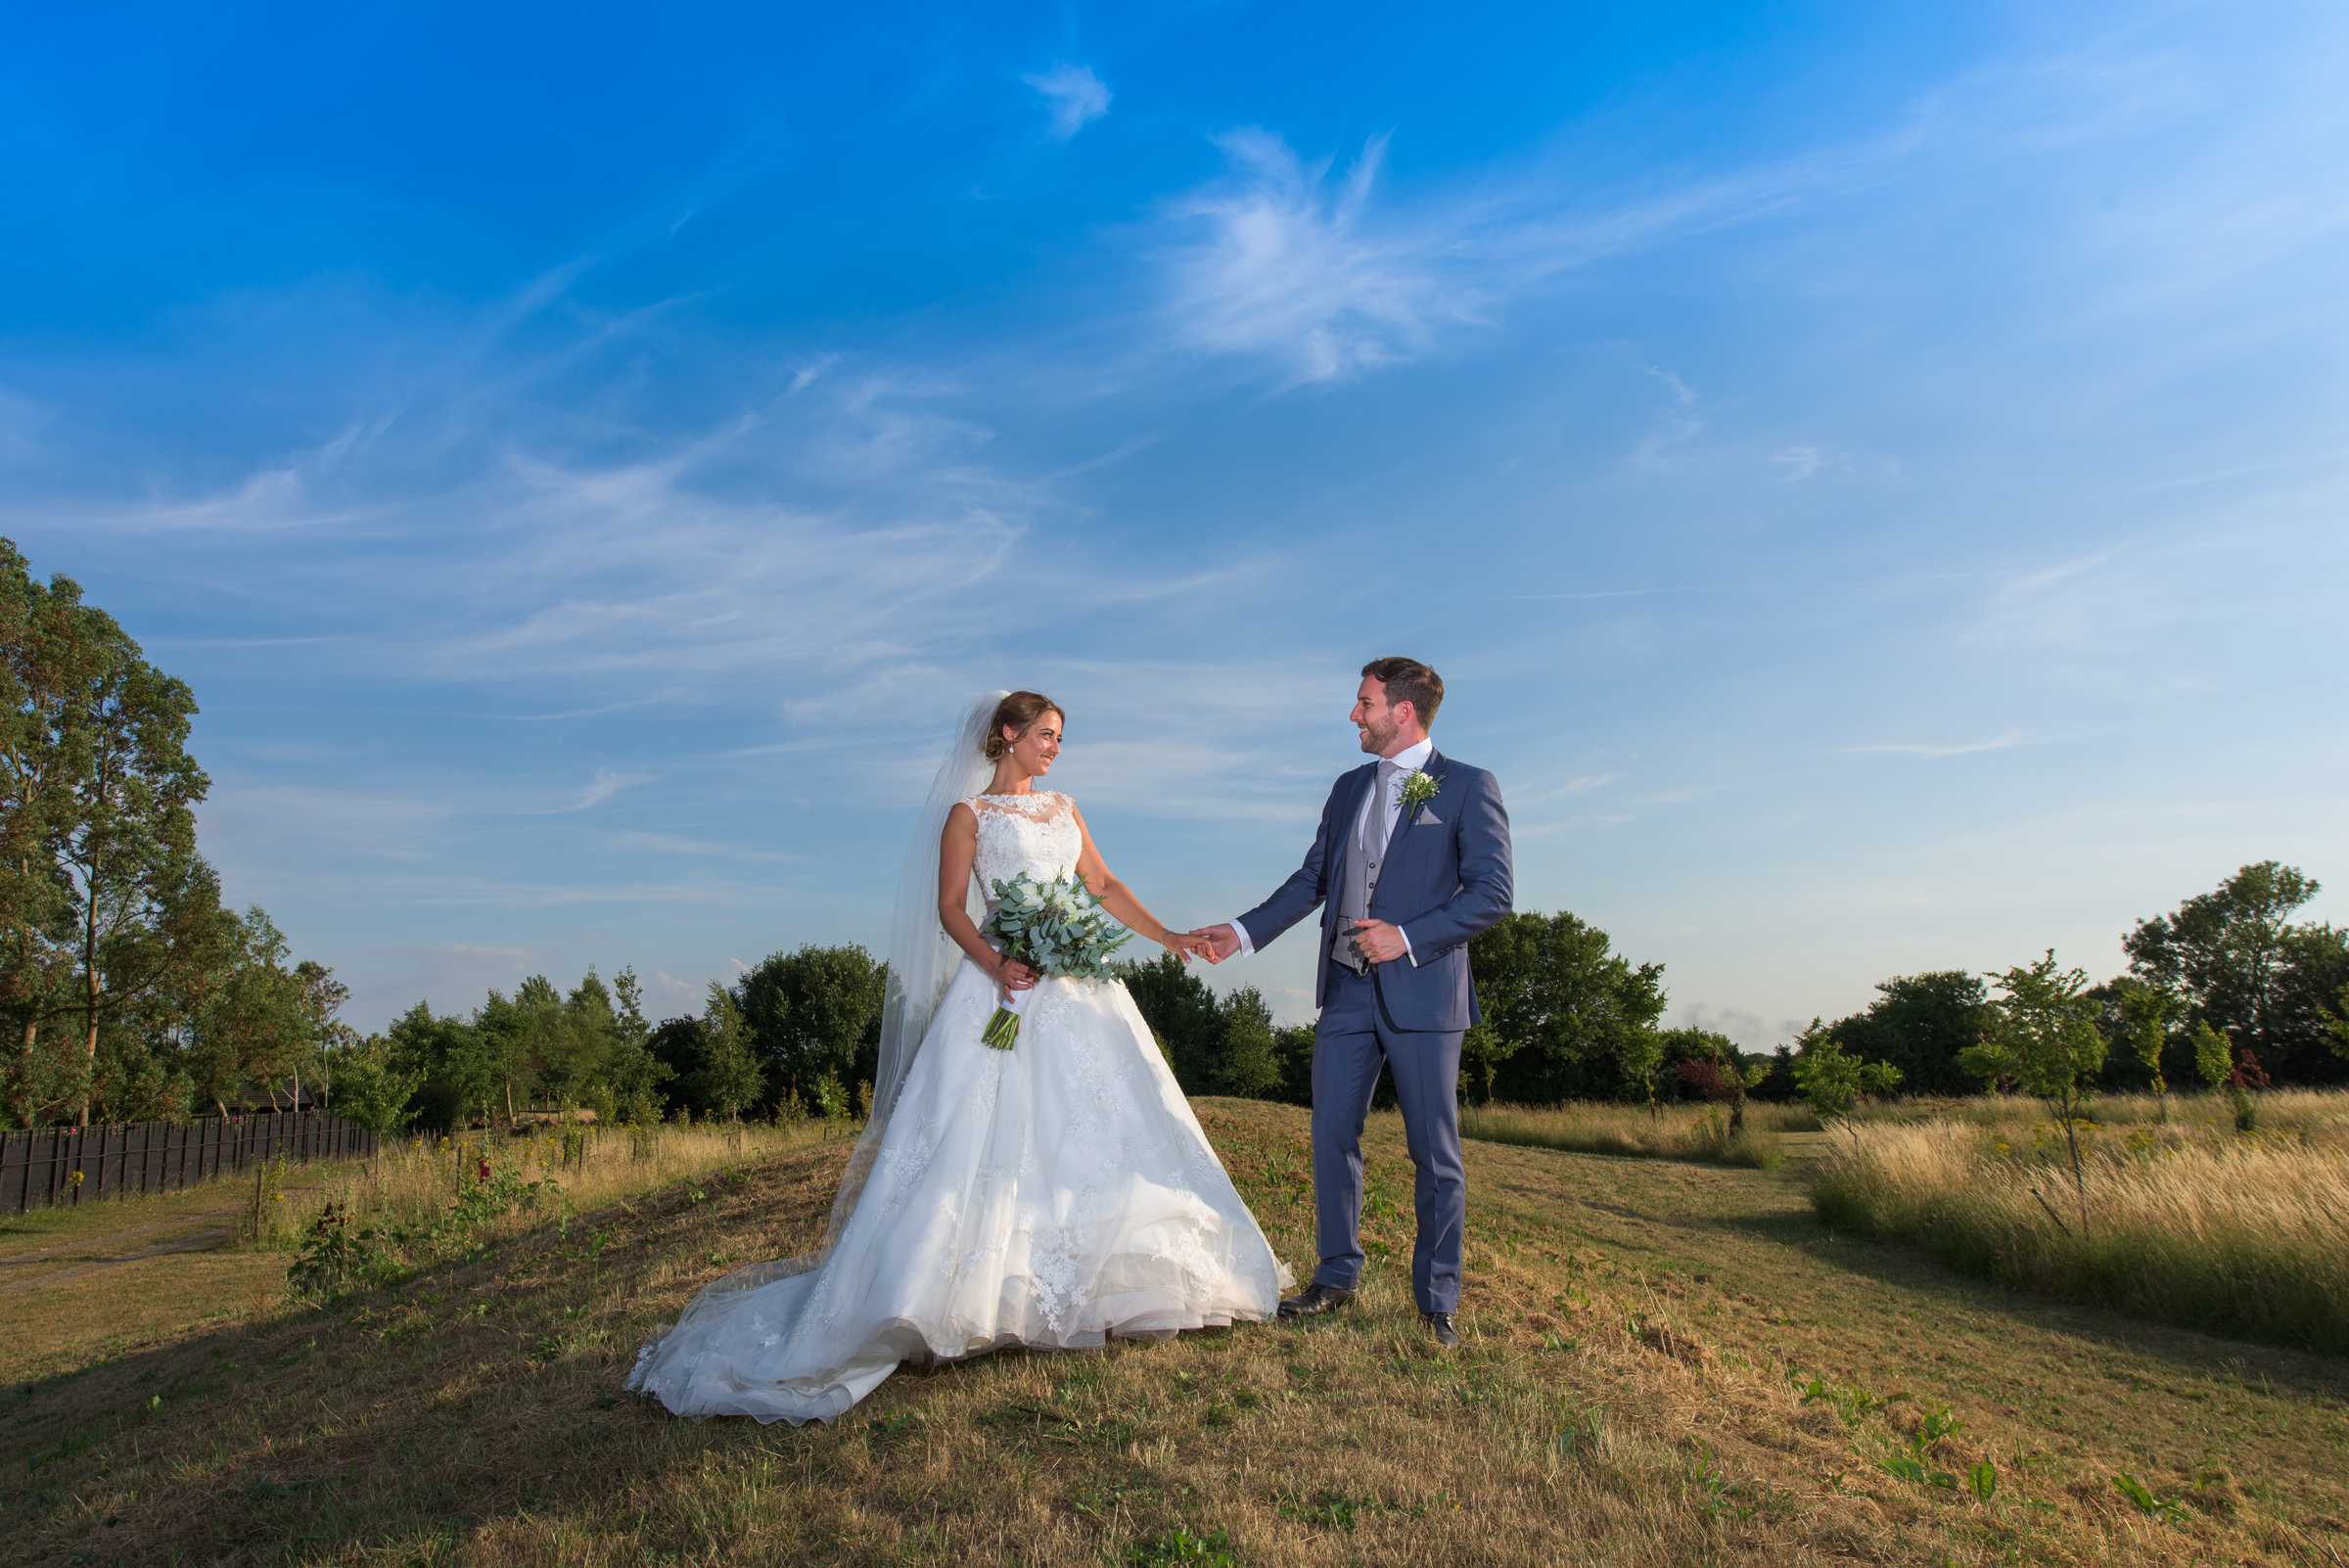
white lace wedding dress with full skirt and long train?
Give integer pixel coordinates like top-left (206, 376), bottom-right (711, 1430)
top-left (627, 794), bottom-right (1292, 1422)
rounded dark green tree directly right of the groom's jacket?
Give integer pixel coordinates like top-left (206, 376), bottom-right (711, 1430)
top-left (1463, 911), bottom-right (1666, 1103)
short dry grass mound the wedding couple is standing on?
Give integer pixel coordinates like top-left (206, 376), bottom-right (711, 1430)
top-left (0, 1101), bottom-right (2349, 1566)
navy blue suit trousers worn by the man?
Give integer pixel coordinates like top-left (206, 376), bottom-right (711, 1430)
top-left (1313, 957), bottom-right (1468, 1313)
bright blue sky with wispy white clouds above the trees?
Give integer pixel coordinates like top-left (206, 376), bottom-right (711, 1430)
top-left (0, 5), bottom-right (2349, 1047)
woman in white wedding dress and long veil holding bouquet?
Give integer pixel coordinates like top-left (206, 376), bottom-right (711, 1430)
top-left (627, 692), bottom-right (1292, 1422)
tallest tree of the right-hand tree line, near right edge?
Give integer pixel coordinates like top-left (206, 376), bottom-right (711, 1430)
top-left (2121, 859), bottom-right (2344, 1068)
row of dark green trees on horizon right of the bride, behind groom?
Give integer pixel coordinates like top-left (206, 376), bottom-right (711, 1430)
top-left (1108, 861), bottom-right (2349, 1106)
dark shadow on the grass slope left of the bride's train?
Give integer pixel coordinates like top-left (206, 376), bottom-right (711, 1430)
top-left (0, 1157), bottom-right (836, 1561)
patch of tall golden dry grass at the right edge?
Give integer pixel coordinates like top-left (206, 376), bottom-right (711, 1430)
top-left (1811, 1091), bottom-right (2349, 1355)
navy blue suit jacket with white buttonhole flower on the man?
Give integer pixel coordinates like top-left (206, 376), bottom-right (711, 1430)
top-left (1240, 751), bottom-right (1513, 1033)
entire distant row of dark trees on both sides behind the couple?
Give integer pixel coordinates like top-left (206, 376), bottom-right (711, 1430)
top-left (317, 861), bottom-right (2349, 1127)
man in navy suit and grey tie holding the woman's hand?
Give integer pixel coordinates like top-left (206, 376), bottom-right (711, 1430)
top-left (1193, 660), bottom-right (1510, 1348)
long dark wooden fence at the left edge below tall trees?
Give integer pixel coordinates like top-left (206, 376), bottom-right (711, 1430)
top-left (0, 1110), bottom-right (376, 1214)
